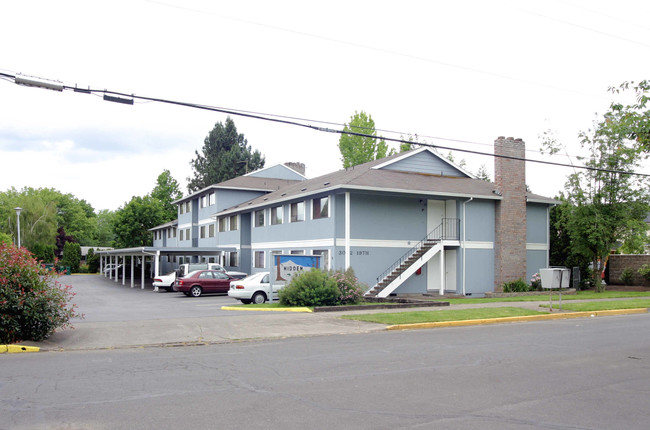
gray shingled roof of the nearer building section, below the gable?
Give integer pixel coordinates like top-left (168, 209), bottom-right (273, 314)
top-left (219, 150), bottom-right (558, 215)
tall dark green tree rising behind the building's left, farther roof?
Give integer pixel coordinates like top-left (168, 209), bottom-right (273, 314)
top-left (187, 118), bottom-right (264, 192)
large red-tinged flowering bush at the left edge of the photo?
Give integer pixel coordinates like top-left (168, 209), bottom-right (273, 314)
top-left (0, 243), bottom-right (83, 343)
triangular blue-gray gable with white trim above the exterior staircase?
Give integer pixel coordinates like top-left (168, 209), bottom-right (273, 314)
top-left (373, 148), bottom-right (474, 179)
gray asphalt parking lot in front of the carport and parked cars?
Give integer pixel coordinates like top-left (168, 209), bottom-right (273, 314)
top-left (69, 275), bottom-right (251, 323)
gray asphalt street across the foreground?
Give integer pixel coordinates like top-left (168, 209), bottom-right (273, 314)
top-left (0, 314), bottom-right (650, 430)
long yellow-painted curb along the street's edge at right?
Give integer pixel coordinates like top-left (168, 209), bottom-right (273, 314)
top-left (386, 308), bottom-right (648, 330)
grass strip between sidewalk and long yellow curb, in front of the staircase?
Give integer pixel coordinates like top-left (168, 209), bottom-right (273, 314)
top-left (341, 307), bottom-right (548, 325)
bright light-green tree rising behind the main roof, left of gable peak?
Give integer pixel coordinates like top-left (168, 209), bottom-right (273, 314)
top-left (339, 111), bottom-right (395, 168)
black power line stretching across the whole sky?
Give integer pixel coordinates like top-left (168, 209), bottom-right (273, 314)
top-left (0, 72), bottom-right (650, 177)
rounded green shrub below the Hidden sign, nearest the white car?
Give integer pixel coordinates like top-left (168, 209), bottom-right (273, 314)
top-left (278, 269), bottom-right (341, 306)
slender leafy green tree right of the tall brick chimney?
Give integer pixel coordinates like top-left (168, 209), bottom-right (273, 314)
top-left (565, 119), bottom-right (650, 291)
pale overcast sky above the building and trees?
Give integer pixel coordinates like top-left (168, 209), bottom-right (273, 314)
top-left (0, 0), bottom-right (650, 210)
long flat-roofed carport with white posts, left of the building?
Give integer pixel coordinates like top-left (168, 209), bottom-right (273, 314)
top-left (97, 246), bottom-right (237, 289)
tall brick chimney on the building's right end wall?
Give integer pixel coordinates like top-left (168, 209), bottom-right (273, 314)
top-left (494, 136), bottom-right (526, 291)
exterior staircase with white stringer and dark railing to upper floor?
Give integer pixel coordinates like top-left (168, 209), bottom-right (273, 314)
top-left (365, 218), bottom-right (459, 297)
